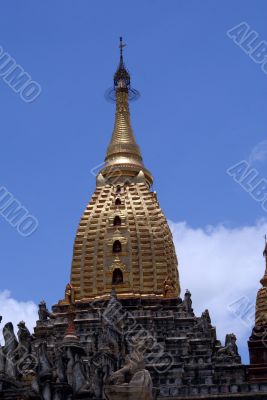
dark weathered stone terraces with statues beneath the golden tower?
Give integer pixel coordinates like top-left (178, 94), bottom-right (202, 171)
top-left (0, 292), bottom-right (267, 400)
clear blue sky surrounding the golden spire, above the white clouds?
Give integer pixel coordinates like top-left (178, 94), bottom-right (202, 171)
top-left (0, 0), bottom-right (267, 362)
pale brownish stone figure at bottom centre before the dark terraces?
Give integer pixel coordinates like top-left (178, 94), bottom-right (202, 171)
top-left (105, 350), bottom-right (152, 400)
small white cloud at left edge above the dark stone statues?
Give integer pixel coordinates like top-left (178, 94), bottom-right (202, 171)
top-left (0, 290), bottom-right (38, 341)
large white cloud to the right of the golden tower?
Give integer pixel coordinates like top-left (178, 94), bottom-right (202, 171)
top-left (170, 220), bottom-right (267, 361)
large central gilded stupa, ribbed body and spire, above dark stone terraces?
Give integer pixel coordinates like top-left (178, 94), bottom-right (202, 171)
top-left (71, 40), bottom-right (180, 301)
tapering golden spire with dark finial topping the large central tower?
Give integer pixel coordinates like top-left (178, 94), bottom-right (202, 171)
top-left (101, 38), bottom-right (153, 185)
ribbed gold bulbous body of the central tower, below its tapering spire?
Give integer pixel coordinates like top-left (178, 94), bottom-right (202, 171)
top-left (71, 183), bottom-right (180, 300)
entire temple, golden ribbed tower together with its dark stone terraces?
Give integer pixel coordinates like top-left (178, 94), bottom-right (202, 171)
top-left (0, 40), bottom-right (267, 400)
